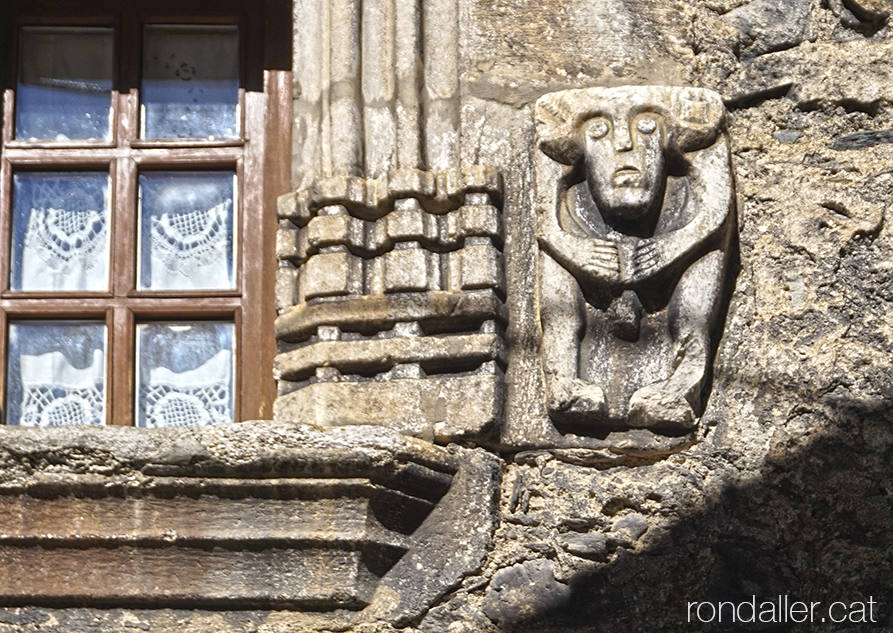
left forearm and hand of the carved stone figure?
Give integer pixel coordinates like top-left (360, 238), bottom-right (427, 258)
top-left (537, 200), bottom-right (620, 287)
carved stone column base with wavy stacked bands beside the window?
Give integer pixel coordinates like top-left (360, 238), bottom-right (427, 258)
top-left (274, 166), bottom-right (506, 442)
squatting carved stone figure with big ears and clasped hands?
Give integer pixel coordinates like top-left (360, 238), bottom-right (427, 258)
top-left (536, 86), bottom-right (735, 435)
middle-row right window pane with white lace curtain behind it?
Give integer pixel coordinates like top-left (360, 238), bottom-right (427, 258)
top-left (139, 172), bottom-right (236, 290)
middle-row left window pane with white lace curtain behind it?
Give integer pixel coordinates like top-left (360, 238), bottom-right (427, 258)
top-left (10, 172), bottom-right (109, 291)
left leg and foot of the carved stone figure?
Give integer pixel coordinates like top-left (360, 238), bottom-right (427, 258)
top-left (539, 252), bottom-right (607, 424)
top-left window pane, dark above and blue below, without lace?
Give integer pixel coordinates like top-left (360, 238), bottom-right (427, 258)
top-left (15, 26), bottom-right (114, 141)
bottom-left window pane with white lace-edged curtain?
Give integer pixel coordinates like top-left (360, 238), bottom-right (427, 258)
top-left (6, 321), bottom-right (106, 426)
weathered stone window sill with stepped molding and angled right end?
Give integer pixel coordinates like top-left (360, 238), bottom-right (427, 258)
top-left (0, 422), bottom-right (498, 630)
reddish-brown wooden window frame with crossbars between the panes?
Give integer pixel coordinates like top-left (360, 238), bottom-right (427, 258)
top-left (0, 0), bottom-right (291, 426)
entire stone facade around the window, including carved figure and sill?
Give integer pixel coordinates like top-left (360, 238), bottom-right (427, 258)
top-left (0, 0), bottom-right (893, 633)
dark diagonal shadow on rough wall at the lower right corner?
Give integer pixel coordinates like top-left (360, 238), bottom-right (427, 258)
top-left (488, 396), bottom-right (893, 633)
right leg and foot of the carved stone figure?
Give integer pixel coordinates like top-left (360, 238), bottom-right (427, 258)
top-left (629, 250), bottom-right (726, 429)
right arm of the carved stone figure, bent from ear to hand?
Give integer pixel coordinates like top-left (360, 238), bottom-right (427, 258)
top-left (629, 137), bottom-right (733, 282)
